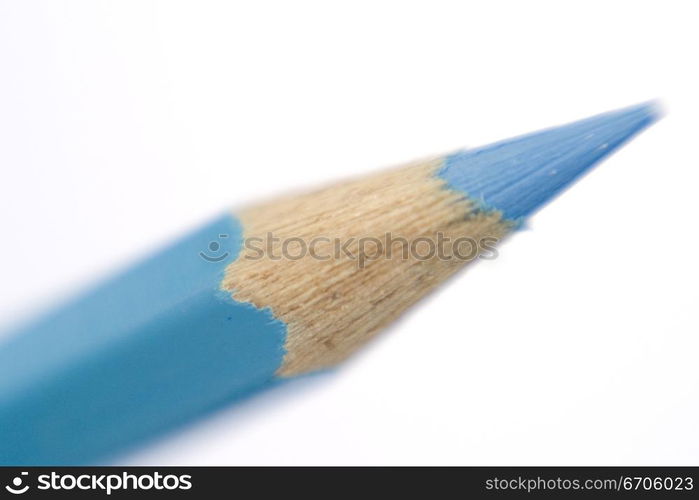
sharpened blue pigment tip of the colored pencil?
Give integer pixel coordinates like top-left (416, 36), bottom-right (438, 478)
top-left (437, 104), bottom-right (658, 221)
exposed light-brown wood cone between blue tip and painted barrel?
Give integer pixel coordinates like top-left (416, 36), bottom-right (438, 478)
top-left (223, 158), bottom-right (513, 376)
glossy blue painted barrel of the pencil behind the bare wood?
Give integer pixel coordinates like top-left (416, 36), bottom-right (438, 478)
top-left (0, 215), bottom-right (286, 465)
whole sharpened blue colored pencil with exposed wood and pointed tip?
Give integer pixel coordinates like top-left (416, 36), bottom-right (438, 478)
top-left (0, 104), bottom-right (657, 465)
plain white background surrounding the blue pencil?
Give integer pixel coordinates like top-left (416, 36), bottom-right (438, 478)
top-left (0, 0), bottom-right (699, 465)
